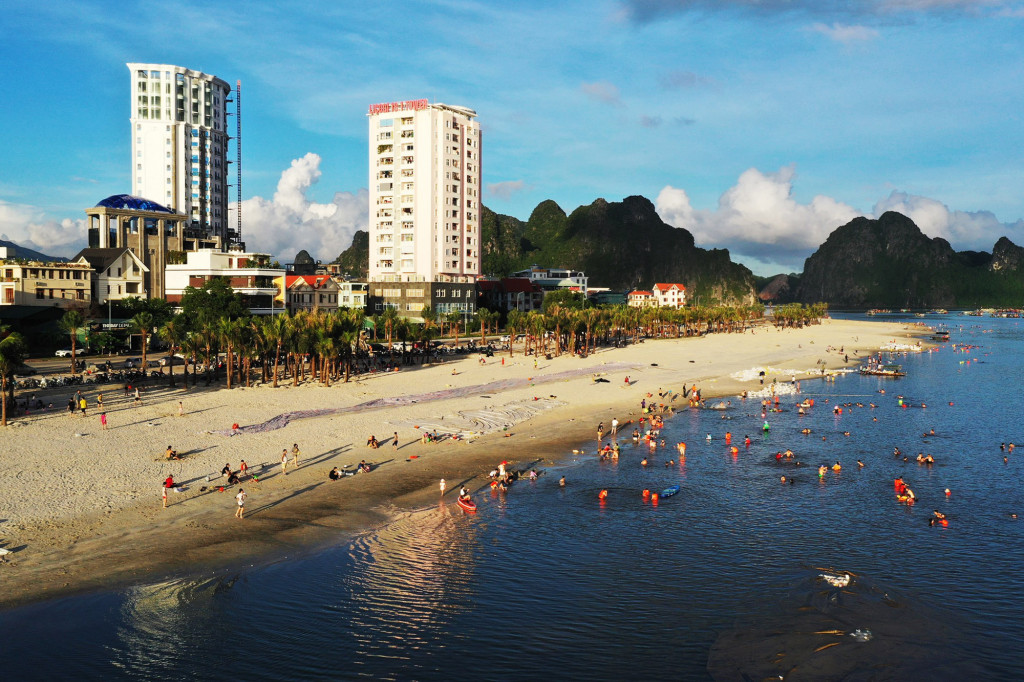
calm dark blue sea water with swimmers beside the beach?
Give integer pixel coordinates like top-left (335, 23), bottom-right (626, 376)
top-left (0, 315), bottom-right (1024, 681)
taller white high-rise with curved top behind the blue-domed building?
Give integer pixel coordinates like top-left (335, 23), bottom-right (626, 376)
top-left (128, 63), bottom-right (232, 244)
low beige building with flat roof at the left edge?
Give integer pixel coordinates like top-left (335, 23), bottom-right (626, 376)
top-left (0, 258), bottom-right (92, 308)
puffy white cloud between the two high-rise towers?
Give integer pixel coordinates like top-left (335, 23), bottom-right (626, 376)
top-left (236, 153), bottom-right (370, 263)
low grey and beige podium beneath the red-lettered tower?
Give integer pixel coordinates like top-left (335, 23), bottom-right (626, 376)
top-left (367, 282), bottom-right (476, 323)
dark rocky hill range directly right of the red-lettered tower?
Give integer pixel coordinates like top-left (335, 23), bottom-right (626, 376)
top-left (481, 197), bottom-right (756, 303)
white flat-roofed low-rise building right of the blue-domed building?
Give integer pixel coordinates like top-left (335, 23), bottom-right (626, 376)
top-left (166, 249), bottom-right (285, 314)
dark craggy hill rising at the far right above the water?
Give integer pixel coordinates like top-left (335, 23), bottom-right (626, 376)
top-left (797, 212), bottom-right (1024, 308)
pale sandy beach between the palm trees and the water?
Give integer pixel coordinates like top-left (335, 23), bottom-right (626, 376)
top-left (0, 319), bottom-right (927, 606)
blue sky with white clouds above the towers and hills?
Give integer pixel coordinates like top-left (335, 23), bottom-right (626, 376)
top-left (0, 0), bottom-right (1024, 274)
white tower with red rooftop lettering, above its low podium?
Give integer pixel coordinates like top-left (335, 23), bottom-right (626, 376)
top-left (368, 99), bottom-right (481, 282)
